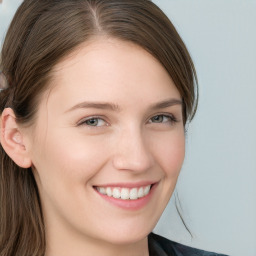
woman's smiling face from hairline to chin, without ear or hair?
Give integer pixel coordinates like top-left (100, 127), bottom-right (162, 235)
top-left (25, 38), bottom-right (184, 252)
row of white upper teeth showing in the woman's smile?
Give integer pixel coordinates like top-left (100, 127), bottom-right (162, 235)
top-left (95, 185), bottom-right (152, 200)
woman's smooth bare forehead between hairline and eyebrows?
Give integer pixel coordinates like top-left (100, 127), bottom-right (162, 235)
top-left (44, 38), bottom-right (180, 111)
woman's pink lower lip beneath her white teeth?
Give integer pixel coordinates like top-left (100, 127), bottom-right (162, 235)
top-left (95, 184), bottom-right (157, 211)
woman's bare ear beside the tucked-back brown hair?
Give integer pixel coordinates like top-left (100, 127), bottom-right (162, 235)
top-left (0, 108), bottom-right (32, 168)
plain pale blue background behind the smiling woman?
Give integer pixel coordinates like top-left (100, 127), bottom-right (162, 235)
top-left (0, 0), bottom-right (256, 256)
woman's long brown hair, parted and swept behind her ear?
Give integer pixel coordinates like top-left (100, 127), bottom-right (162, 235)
top-left (0, 0), bottom-right (197, 256)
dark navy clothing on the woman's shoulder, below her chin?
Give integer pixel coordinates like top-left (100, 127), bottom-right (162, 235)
top-left (148, 233), bottom-right (227, 256)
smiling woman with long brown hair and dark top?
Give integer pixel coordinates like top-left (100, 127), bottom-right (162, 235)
top-left (0, 0), bottom-right (226, 256)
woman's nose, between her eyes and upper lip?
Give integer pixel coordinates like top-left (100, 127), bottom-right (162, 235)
top-left (113, 129), bottom-right (153, 172)
